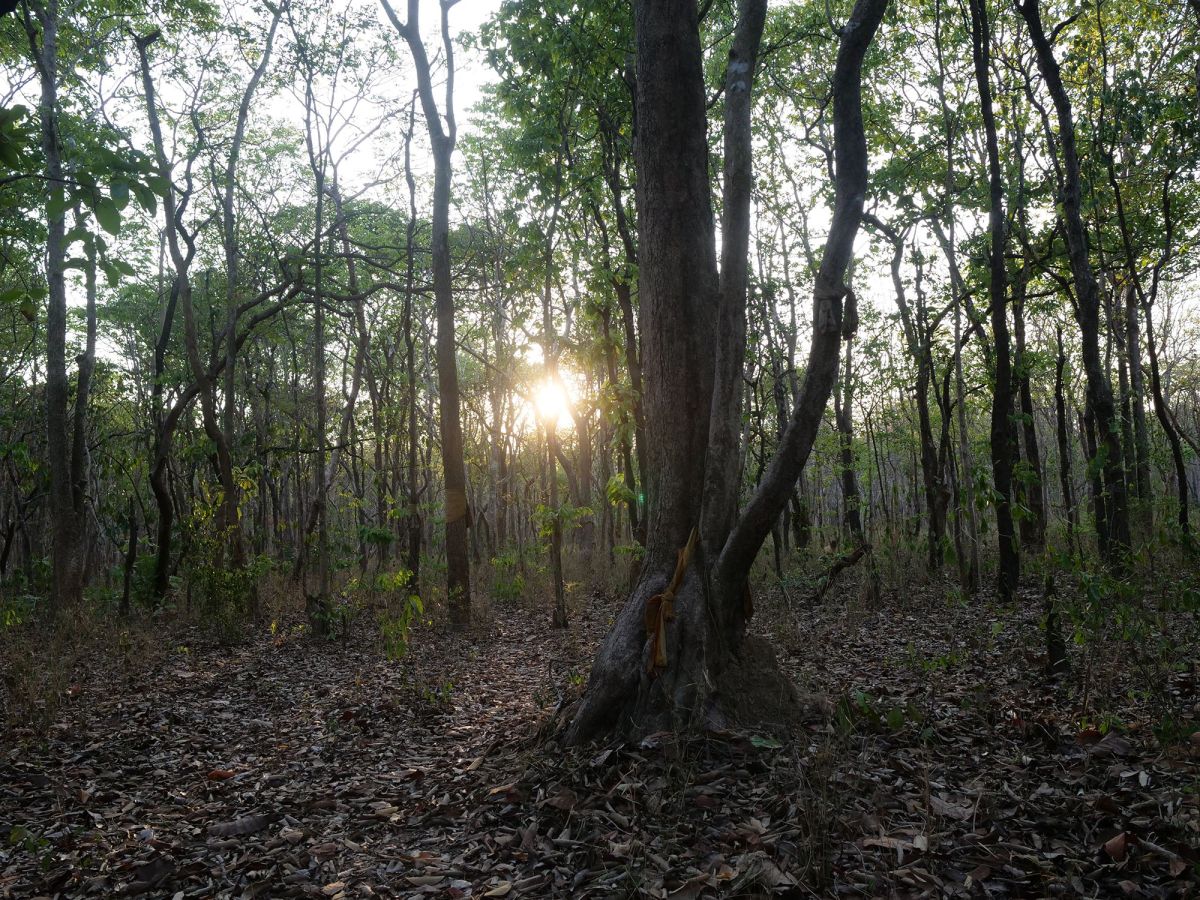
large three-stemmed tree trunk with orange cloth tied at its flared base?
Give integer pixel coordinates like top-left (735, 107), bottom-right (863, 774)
top-left (566, 0), bottom-right (887, 743)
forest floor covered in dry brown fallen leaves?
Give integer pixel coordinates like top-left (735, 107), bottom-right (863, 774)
top-left (0, 566), bottom-right (1200, 899)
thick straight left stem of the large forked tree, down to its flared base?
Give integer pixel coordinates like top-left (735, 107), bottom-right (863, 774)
top-left (561, 0), bottom-right (739, 740)
